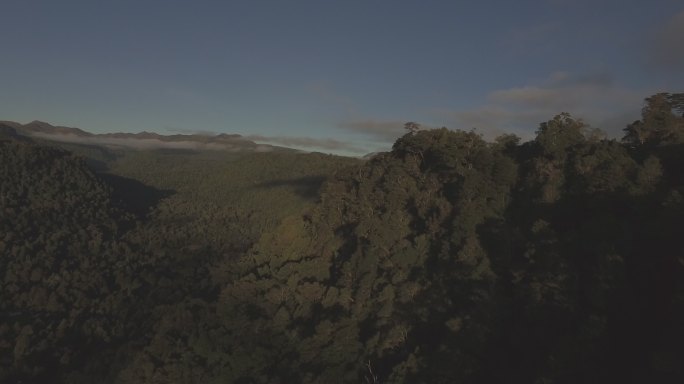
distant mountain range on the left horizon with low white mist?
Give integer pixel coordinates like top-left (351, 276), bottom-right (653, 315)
top-left (0, 120), bottom-right (296, 152)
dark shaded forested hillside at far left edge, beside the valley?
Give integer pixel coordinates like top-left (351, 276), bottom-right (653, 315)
top-left (0, 131), bottom-right (144, 382)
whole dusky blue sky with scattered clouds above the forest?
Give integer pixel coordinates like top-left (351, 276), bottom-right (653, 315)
top-left (0, 0), bottom-right (684, 155)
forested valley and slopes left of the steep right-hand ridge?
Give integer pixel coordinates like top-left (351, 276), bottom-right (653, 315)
top-left (0, 126), bottom-right (359, 383)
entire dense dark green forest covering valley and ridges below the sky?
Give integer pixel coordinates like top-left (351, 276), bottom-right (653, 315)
top-left (0, 93), bottom-right (684, 383)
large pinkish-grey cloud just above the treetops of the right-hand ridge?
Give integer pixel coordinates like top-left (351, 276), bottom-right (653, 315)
top-left (434, 72), bottom-right (648, 139)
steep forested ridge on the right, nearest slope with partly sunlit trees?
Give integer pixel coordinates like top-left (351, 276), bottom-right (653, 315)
top-left (215, 103), bottom-right (684, 383)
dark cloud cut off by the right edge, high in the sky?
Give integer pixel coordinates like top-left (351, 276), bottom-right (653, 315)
top-left (650, 11), bottom-right (684, 73)
